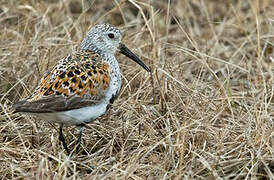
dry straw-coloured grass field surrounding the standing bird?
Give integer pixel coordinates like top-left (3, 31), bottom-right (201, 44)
top-left (0, 0), bottom-right (274, 179)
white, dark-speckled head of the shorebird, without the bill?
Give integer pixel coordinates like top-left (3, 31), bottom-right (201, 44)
top-left (81, 24), bottom-right (122, 55)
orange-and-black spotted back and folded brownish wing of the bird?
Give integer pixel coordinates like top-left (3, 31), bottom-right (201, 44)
top-left (13, 51), bottom-right (110, 113)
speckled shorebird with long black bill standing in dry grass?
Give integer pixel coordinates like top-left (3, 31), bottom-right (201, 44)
top-left (13, 24), bottom-right (151, 154)
